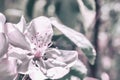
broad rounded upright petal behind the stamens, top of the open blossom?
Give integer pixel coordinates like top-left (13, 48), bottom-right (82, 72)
top-left (33, 16), bottom-right (53, 45)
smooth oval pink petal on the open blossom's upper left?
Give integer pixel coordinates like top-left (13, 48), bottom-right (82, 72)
top-left (6, 23), bottom-right (30, 50)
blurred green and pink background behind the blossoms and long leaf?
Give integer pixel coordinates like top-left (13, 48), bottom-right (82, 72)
top-left (0, 0), bottom-right (120, 80)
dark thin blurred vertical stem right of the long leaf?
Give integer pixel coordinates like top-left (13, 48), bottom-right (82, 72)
top-left (90, 0), bottom-right (101, 78)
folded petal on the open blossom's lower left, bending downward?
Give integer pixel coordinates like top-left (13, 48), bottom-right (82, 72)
top-left (8, 47), bottom-right (32, 74)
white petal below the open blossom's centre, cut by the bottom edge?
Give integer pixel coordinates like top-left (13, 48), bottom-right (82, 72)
top-left (29, 61), bottom-right (47, 80)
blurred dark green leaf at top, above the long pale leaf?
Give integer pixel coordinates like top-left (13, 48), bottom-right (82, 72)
top-left (55, 0), bottom-right (80, 28)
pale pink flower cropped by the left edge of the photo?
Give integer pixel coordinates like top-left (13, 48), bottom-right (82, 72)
top-left (0, 13), bottom-right (17, 80)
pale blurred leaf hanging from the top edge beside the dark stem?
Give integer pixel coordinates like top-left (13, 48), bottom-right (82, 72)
top-left (77, 0), bottom-right (96, 30)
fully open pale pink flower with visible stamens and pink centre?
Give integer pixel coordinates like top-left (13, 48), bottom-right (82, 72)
top-left (5, 16), bottom-right (78, 80)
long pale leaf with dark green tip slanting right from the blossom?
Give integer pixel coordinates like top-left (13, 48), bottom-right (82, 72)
top-left (52, 20), bottom-right (96, 64)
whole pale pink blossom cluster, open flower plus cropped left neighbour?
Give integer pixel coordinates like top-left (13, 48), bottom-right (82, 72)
top-left (0, 13), bottom-right (78, 80)
